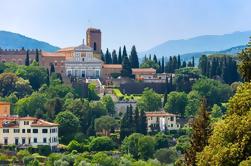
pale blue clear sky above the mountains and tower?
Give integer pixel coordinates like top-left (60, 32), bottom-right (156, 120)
top-left (0, 0), bottom-right (251, 51)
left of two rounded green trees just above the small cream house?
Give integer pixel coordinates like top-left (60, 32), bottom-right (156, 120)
top-left (137, 88), bottom-right (161, 112)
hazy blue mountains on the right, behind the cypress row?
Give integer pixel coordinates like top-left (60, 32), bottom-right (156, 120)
top-left (139, 31), bottom-right (251, 57)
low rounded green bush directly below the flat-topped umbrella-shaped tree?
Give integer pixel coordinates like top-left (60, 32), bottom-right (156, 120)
top-left (90, 137), bottom-right (116, 151)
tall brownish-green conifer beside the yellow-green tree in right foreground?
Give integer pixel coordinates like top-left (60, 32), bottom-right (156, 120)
top-left (185, 98), bottom-right (210, 166)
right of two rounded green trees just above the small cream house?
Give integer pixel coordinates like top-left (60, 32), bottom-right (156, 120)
top-left (164, 91), bottom-right (187, 115)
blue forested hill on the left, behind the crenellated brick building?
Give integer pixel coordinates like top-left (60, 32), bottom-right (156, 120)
top-left (0, 31), bottom-right (59, 52)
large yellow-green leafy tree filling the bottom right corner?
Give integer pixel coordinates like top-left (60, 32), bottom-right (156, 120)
top-left (197, 83), bottom-right (251, 165)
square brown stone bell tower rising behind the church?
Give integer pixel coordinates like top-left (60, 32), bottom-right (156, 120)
top-left (86, 28), bottom-right (101, 58)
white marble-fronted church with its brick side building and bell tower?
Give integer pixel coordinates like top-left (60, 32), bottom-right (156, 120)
top-left (41, 28), bottom-right (103, 79)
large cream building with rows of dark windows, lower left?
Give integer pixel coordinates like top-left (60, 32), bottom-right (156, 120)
top-left (0, 103), bottom-right (59, 149)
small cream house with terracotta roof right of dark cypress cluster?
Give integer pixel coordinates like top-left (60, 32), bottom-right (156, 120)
top-left (146, 111), bottom-right (180, 132)
